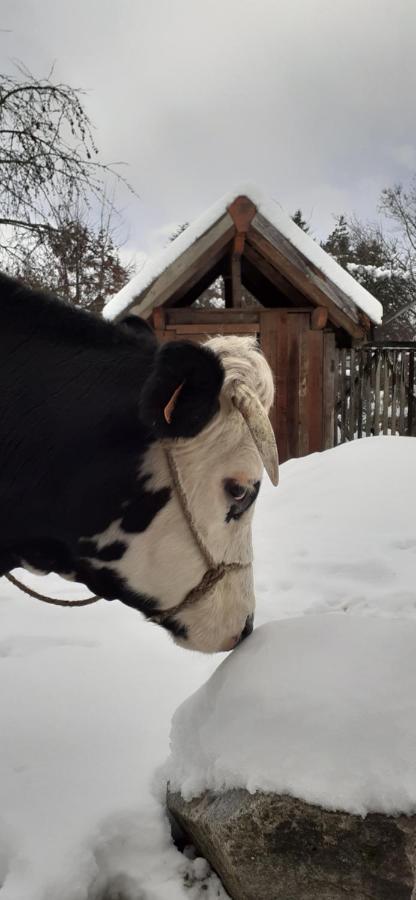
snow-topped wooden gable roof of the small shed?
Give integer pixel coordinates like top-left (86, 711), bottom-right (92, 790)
top-left (104, 186), bottom-right (383, 337)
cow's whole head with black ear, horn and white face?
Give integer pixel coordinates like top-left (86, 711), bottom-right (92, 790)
top-left (97, 336), bottom-right (277, 653)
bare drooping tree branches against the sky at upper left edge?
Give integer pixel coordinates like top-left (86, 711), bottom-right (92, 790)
top-left (0, 66), bottom-right (132, 253)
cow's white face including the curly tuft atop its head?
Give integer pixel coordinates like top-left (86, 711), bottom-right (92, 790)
top-left (102, 337), bottom-right (273, 653)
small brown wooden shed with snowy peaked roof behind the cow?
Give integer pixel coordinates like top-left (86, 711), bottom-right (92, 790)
top-left (105, 191), bottom-right (382, 462)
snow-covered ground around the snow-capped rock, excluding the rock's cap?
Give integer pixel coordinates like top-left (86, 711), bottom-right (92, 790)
top-left (0, 437), bottom-right (416, 900)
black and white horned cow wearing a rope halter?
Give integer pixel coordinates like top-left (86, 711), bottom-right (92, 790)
top-left (0, 275), bottom-right (277, 652)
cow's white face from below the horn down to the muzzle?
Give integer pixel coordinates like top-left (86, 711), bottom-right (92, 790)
top-left (133, 411), bottom-right (263, 653)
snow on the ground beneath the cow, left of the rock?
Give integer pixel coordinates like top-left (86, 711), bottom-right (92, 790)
top-left (0, 572), bottom-right (226, 900)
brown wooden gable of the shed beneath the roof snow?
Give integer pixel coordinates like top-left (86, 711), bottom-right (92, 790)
top-left (119, 195), bottom-right (371, 341)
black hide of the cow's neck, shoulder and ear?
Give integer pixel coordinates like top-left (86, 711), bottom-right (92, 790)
top-left (0, 274), bottom-right (223, 630)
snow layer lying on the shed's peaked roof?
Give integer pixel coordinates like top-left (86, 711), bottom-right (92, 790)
top-left (103, 184), bottom-right (383, 324)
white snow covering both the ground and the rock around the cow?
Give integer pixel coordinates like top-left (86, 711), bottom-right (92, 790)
top-left (0, 437), bottom-right (416, 900)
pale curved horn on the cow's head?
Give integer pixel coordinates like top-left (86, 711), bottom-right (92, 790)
top-left (233, 382), bottom-right (279, 484)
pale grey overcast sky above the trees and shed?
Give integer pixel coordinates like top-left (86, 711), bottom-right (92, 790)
top-left (0, 0), bottom-right (416, 264)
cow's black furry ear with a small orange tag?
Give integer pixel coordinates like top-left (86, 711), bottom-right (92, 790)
top-left (140, 341), bottom-right (224, 438)
